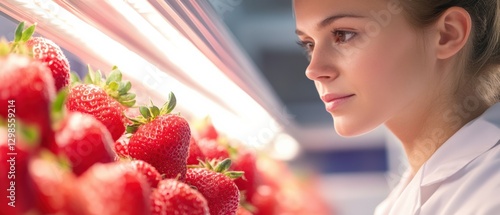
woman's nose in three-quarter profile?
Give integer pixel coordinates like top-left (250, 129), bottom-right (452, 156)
top-left (306, 47), bottom-right (338, 81)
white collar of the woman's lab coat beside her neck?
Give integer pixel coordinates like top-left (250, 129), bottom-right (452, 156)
top-left (420, 102), bottom-right (500, 186)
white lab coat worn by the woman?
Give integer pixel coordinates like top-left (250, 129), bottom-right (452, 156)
top-left (375, 103), bottom-right (500, 215)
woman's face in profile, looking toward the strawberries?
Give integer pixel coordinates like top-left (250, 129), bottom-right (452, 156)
top-left (294, 0), bottom-right (435, 136)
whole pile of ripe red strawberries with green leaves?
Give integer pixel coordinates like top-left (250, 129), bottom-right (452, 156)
top-left (0, 23), bottom-right (336, 215)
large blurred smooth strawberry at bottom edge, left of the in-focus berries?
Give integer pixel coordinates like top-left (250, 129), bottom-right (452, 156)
top-left (75, 162), bottom-right (151, 215)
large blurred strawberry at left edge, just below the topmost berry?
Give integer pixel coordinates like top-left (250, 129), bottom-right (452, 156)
top-left (0, 54), bottom-right (56, 150)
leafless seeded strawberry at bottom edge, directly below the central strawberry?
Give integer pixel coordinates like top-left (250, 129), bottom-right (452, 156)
top-left (151, 179), bottom-right (210, 215)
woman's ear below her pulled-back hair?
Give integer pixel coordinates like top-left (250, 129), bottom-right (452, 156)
top-left (436, 7), bottom-right (472, 59)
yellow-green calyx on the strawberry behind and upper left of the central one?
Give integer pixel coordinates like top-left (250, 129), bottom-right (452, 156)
top-left (82, 66), bottom-right (135, 107)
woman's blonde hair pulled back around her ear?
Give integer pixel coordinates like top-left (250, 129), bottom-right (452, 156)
top-left (398, 0), bottom-right (500, 105)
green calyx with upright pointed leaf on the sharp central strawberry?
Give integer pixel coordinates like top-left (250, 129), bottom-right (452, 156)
top-left (127, 92), bottom-right (177, 134)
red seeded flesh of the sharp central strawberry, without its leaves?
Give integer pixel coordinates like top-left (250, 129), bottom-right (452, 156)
top-left (129, 114), bottom-right (191, 181)
